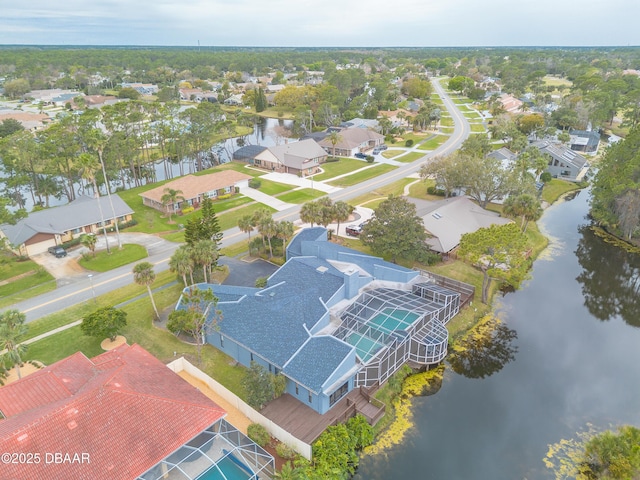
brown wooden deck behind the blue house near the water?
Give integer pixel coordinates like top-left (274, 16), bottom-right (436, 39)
top-left (260, 388), bottom-right (385, 445)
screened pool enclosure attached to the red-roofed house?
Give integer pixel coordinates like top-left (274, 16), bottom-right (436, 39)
top-left (137, 419), bottom-right (275, 480)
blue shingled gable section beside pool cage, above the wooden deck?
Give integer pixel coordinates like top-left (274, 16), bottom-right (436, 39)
top-left (283, 336), bottom-right (354, 393)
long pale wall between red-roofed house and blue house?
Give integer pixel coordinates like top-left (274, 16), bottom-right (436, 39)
top-left (167, 357), bottom-right (311, 460)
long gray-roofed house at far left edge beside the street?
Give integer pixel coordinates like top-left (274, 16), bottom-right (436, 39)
top-left (0, 194), bottom-right (133, 256)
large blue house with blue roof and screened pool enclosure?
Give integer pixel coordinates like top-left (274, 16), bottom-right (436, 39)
top-left (176, 227), bottom-right (468, 414)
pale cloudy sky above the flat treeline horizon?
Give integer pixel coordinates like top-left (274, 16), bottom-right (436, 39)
top-left (0, 0), bottom-right (640, 47)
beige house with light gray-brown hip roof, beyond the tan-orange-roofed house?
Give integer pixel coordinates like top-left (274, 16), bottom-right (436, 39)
top-left (253, 139), bottom-right (327, 176)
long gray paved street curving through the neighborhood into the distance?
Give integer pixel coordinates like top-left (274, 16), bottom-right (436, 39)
top-left (6, 80), bottom-right (471, 322)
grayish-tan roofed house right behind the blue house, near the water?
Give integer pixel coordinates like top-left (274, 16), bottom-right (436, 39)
top-left (409, 196), bottom-right (511, 255)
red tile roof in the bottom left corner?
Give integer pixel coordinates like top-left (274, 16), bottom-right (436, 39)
top-left (0, 345), bottom-right (225, 480)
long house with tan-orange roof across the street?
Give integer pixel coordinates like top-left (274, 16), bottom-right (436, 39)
top-left (139, 170), bottom-right (251, 214)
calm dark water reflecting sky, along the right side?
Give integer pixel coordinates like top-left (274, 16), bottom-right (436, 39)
top-left (356, 191), bottom-right (640, 480)
